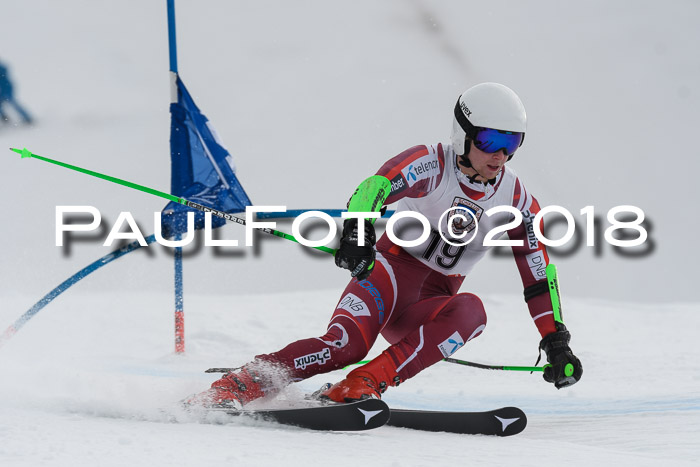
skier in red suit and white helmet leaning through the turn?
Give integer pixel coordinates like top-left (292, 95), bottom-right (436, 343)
top-left (187, 83), bottom-right (583, 408)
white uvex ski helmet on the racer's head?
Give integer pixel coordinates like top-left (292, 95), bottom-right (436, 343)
top-left (452, 83), bottom-right (527, 160)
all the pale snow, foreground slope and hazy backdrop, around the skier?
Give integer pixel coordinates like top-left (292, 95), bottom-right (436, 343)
top-left (0, 0), bottom-right (700, 466)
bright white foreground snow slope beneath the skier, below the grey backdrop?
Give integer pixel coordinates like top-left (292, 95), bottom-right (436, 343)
top-left (0, 292), bottom-right (700, 466)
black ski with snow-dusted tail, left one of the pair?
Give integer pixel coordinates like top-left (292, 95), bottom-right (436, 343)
top-left (213, 399), bottom-right (390, 431)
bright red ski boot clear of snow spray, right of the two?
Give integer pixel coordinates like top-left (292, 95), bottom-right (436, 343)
top-left (321, 352), bottom-right (401, 402)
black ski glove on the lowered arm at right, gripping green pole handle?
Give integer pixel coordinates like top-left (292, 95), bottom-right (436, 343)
top-left (540, 323), bottom-right (583, 389)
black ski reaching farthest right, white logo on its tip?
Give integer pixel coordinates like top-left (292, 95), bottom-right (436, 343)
top-left (387, 407), bottom-right (527, 436)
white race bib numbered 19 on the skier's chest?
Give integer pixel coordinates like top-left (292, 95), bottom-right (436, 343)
top-left (393, 144), bottom-right (517, 276)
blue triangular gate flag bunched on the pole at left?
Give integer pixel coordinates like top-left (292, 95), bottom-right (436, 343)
top-left (161, 74), bottom-right (252, 238)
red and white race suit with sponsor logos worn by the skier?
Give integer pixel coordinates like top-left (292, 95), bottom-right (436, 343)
top-left (256, 144), bottom-right (555, 381)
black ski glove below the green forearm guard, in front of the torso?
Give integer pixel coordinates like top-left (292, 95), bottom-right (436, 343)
top-left (335, 219), bottom-right (377, 281)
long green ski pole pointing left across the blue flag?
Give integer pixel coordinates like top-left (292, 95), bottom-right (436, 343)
top-left (10, 148), bottom-right (335, 255)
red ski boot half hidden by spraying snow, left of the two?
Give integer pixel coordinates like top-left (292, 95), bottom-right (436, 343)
top-left (185, 366), bottom-right (266, 409)
